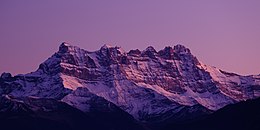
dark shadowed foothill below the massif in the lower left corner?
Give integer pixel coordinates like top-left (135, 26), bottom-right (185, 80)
top-left (0, 95), bottom-right (143, 130)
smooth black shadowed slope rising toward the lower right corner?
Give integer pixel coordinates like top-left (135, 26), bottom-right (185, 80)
top-left (163, 99), bottom-right (260, 130)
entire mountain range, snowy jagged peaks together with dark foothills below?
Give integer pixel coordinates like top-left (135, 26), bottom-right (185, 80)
top-left (0, 42), bottom-right (260, 130)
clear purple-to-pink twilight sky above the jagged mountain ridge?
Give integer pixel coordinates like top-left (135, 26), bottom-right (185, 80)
top-left (0, 0), bottom-right (260, 75)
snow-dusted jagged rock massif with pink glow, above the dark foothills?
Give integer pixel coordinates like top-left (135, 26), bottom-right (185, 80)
top-left (0, 43), bottom-right (260, 122)
